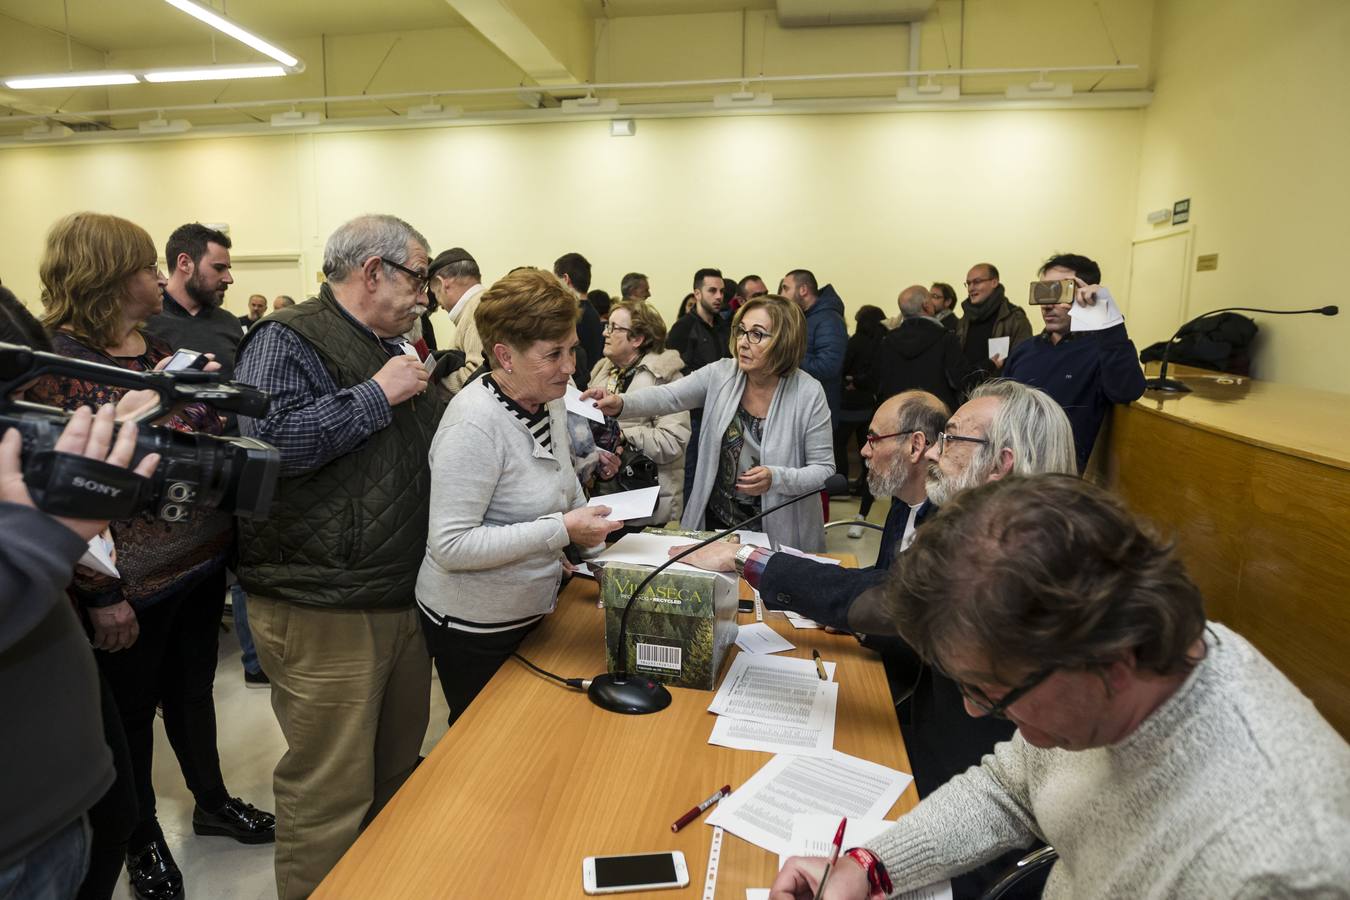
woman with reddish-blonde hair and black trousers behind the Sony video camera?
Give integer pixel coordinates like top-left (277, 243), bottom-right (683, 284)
top-left (28, 212), bottom-right (275, 897)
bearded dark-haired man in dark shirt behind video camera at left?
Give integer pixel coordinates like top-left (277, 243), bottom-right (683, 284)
top-left (146, 223), bottom-right (243, 383)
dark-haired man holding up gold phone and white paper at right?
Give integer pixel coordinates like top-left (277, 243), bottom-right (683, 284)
top-left (1003, 254), bottom-right (1143, 472)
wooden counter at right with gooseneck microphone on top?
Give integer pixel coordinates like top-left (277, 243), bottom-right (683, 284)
top-left (1107, 367), bottom-right (1350, 737)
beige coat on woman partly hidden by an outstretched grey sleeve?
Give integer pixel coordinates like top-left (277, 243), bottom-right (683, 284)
top-left (590, 349), bottom-right (691, 525)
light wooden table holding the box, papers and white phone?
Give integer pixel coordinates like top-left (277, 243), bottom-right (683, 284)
top-left (313, 558), bottom-right (918, 900)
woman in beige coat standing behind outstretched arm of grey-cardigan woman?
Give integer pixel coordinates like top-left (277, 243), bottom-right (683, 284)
top-left (590, 300), bottom-right (690, 528)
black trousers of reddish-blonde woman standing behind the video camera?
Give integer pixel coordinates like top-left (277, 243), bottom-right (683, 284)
top-left (95, 567), bottom-right (228, 850)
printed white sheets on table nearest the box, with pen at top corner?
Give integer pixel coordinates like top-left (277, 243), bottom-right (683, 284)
top-left (707, 653), bottom-right (838, 729)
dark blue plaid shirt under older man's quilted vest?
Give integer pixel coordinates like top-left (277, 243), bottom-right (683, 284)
top-left (235, 321), bottom-right (400, 478)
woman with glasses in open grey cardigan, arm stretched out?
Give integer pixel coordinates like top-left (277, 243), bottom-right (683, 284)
top-left (586, 294), bottom-right (834, 551)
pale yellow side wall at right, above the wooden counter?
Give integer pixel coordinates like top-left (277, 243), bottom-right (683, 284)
top-left (1130, 0), bottom-right (1350, 391)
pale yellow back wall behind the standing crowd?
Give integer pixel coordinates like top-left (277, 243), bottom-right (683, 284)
top-left (0, 111), bottom-right (1142, 340)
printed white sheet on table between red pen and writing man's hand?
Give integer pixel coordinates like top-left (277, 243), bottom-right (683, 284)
top-left (705, 750), bottom-right (913, 854)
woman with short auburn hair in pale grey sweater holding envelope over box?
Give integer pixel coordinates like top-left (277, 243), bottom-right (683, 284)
top-left (417, 269), bottom-right (621, 725)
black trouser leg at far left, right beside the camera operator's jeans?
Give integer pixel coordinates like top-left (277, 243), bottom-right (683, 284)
top-left (76, 673), bottom-right (139, 900)
